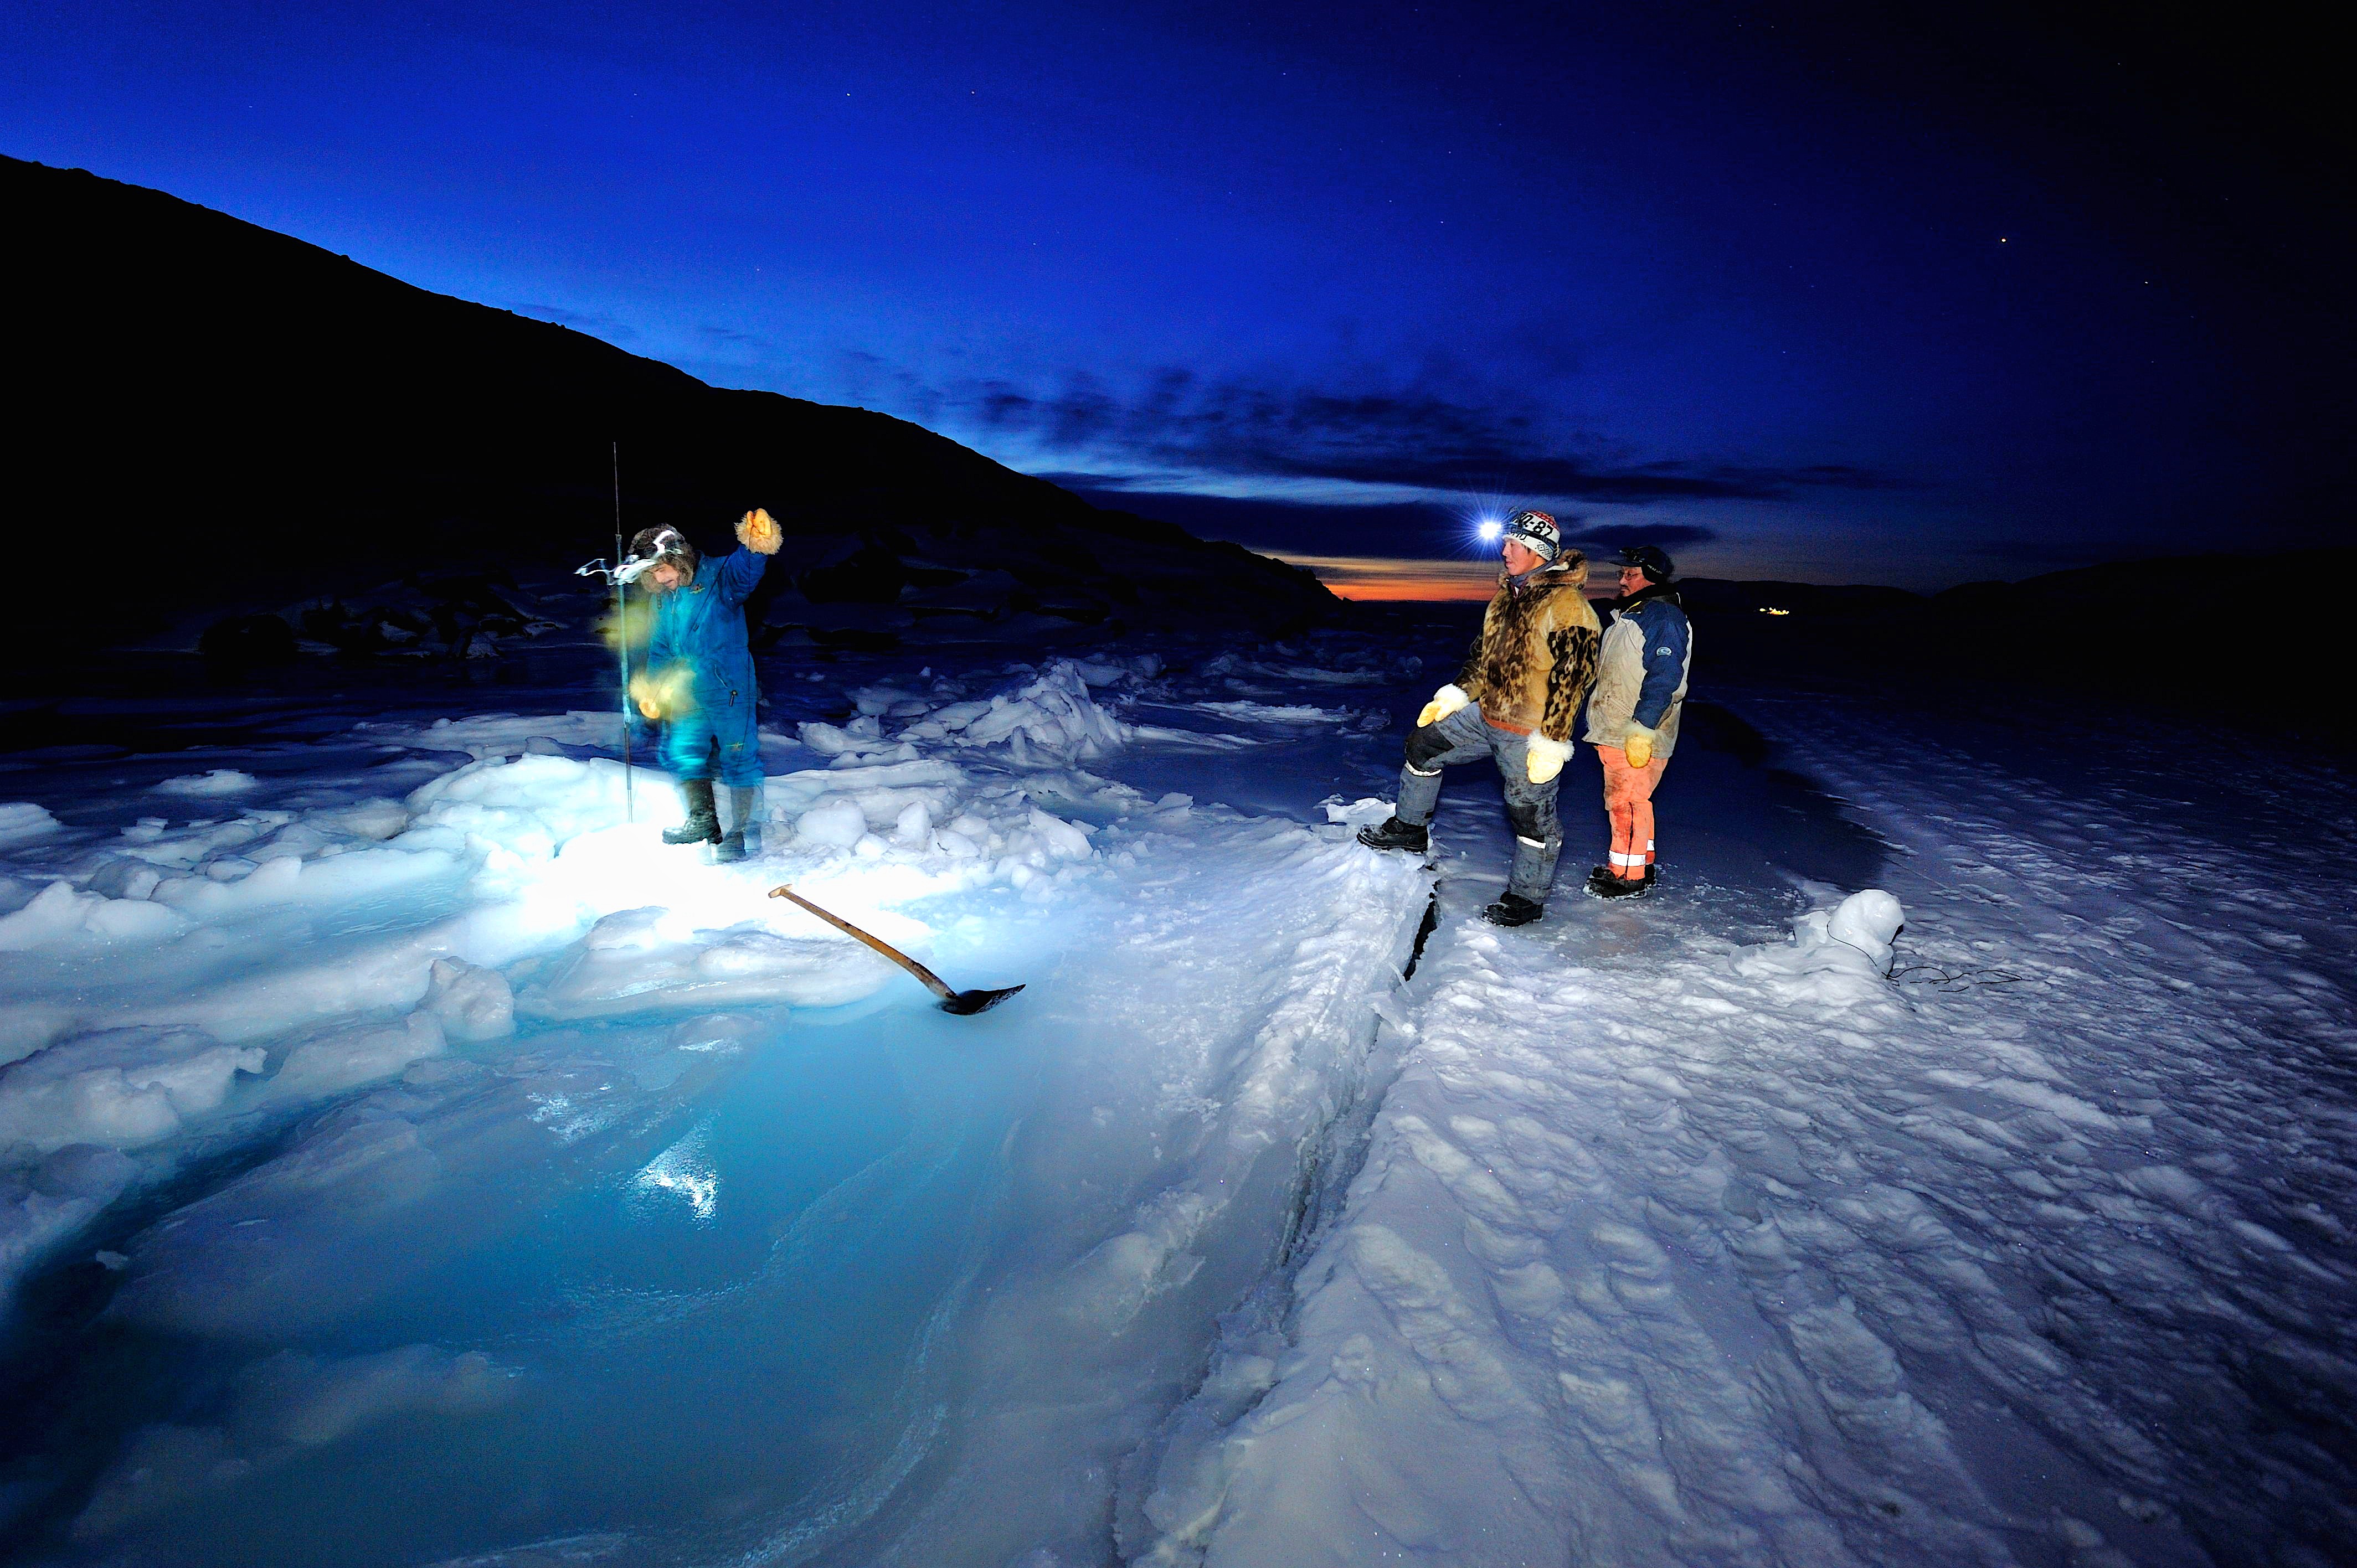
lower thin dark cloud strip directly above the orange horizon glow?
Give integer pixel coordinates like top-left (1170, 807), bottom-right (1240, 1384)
top-left (1042, 490), bottom-right (1718, 559)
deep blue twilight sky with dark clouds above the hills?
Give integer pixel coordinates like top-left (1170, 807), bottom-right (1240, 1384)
top-left (0, 0), bottom-right (2352, 587)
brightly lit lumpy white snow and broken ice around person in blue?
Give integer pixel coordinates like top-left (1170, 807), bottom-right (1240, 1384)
top-left (0, 663), bottom-right (1129, 1306)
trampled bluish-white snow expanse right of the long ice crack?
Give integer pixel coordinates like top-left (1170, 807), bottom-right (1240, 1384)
top-left (1122, 703), bottom-right (2357, 1568)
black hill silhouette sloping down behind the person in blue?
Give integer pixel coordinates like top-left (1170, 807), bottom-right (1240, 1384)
top-left (0, 158), bottom-right (1334, 653)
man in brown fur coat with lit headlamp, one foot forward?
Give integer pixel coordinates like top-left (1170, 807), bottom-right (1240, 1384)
top-left (1357, 512), bottom-right (1598, 927)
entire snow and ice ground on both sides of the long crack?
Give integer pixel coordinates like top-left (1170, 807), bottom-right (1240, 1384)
top-left (0, 646), bottom-right (2357, 1568)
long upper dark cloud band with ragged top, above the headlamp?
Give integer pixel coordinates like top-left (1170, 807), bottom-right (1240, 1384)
top-left (950, 370), bottom-right (1886, 504)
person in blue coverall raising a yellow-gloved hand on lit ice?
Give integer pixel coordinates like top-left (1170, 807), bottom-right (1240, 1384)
top-left (629, 507), bottom-right (785, 860)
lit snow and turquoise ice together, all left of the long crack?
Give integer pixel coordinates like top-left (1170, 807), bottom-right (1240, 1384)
top-left (0, 656), bottom-right (1428, 1563)
